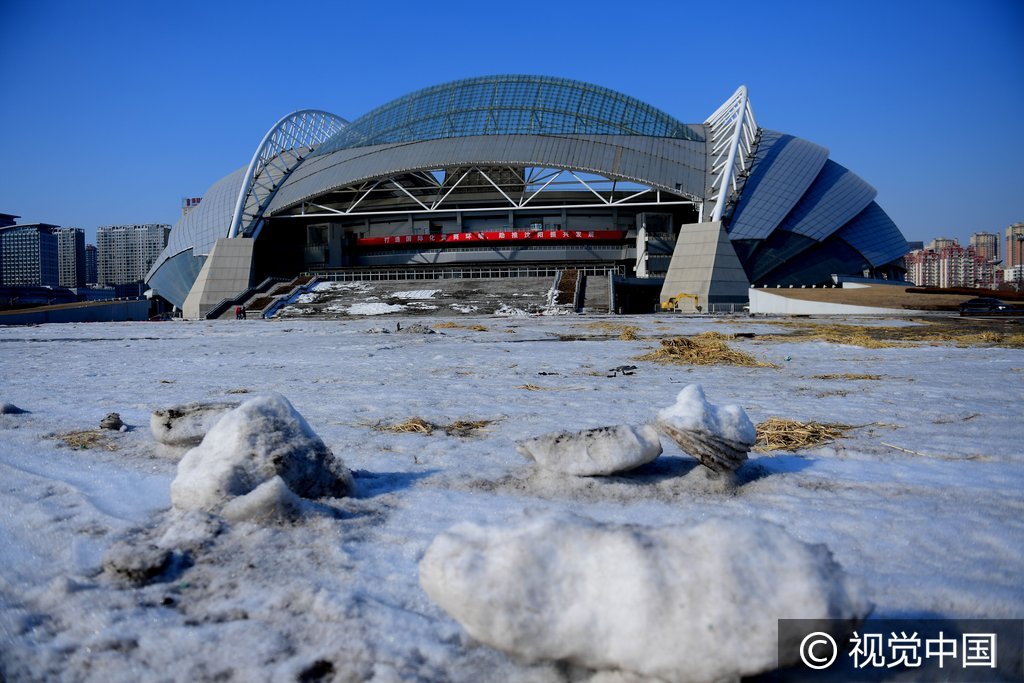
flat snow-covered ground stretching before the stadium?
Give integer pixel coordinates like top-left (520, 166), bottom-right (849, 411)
top-left (0, 313), bottom-right (1024, 681)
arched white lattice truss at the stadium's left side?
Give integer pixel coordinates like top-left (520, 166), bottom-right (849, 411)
top-left (227, 110), bottom-right (348, 238)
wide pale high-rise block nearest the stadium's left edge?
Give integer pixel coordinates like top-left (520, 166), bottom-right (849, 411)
top-left (96, 223), bottom-right (171, 285)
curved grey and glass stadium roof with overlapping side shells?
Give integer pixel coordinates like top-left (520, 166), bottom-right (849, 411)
top-left (147, 76), bottom-right (906, 305)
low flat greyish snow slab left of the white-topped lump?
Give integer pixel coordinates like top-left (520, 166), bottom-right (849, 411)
top-left (517, 425), bottom-right (662, 476)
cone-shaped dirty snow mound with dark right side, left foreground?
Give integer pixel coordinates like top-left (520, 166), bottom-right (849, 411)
top-left (171, 394), bottom-right (353, 519)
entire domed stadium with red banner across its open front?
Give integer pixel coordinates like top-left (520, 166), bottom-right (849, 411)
top-left (146, 76), bottom-right (907, 317)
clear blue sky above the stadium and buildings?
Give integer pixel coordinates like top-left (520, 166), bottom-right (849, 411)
top-left (0, 0), bottom-right (1024, 242)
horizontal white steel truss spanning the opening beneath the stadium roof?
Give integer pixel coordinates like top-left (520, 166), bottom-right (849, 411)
top-left (286, 166), bottom-right (696, 218)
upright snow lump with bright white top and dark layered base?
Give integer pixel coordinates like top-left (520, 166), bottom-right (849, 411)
top-left (657, 384), bottom-right (757, 472)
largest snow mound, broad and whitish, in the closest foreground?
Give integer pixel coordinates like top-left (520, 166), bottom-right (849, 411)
top-left (420, 515), bottom-right (867, 682)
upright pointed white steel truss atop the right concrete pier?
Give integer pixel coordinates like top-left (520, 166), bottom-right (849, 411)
top-left (705, 85), bottom-right (758, 221)
